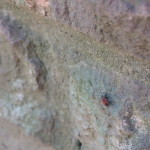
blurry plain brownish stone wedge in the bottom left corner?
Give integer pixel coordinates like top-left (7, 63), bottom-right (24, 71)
top-left (0, 118), bottom-right (54, 150)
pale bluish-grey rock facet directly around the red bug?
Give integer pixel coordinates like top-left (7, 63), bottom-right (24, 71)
top-left (70, 66), bottom-right (150, 150)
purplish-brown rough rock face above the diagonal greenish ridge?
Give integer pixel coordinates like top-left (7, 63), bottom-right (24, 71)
top-left (9, 0), bottom-right (150, 61)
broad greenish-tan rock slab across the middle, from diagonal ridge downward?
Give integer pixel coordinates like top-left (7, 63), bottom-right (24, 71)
top-left (0, 0), bottom-right (150, 150)
